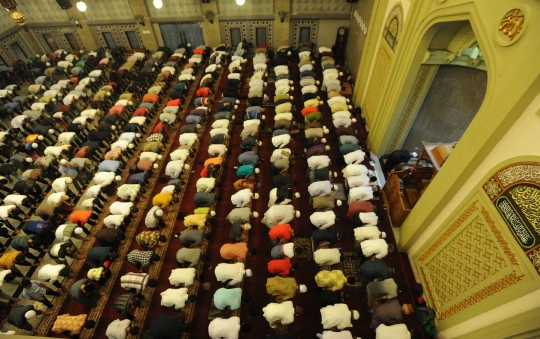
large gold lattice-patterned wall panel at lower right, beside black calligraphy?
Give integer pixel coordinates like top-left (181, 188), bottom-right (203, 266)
top-left (418, 200), bottom-right (523, 320)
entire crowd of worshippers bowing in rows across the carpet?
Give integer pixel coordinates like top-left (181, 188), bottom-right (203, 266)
top-left (0, 38), bottom-right (414, 339)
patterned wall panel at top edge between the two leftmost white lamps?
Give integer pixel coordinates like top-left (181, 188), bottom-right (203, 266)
top-left (84, 0), bottom-right (136, 21)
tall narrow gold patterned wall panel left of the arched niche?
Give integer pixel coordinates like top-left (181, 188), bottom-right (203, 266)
top-left (364, 44), bottom-right (392, 125)
